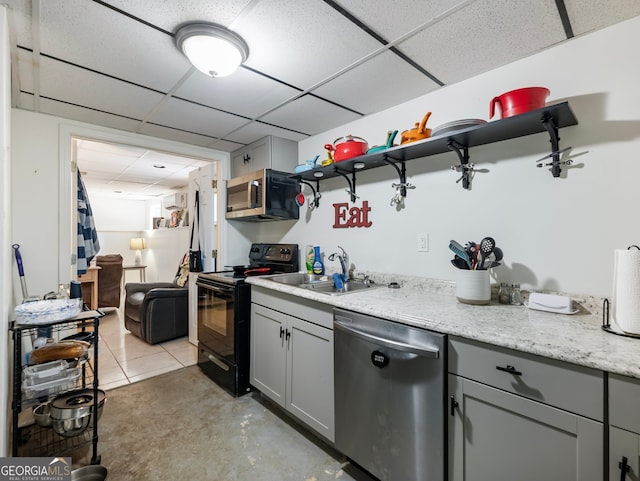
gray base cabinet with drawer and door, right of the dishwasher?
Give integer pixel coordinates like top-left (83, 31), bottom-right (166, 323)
top-left (448, 338), bottom-right (605, 481)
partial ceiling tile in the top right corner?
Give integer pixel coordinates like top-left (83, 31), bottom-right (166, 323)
top-left (564, 0), bottom-right (640, 35)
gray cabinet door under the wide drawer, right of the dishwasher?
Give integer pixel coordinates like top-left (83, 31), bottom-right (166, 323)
top-left (449, 375), bottom-right (604, 481)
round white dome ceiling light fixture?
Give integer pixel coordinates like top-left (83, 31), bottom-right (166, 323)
top-left (175, 22), bottom-right (249, 77)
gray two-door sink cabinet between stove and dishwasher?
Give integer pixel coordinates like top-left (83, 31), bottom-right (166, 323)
top-left (250, 286), bottom-right (335, 442)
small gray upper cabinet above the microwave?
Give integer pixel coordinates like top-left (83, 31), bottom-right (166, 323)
top-left (231, 135), bottom-right (298, 177)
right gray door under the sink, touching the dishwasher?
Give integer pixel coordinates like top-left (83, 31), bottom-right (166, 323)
top-left (287, 317), bottom-right (335, 441)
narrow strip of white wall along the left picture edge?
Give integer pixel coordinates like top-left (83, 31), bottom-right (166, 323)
top-left (0, 5), bottom-right (13, 456)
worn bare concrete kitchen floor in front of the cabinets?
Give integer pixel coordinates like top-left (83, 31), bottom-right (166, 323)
top-left (72, 366), bottom-right (378, 481)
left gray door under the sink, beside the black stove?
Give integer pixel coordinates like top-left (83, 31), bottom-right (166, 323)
top-left (249, 304), bottom-right (288, 407)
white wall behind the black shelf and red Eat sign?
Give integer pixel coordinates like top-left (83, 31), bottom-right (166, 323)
top-left (264, 17), bottom-right (640, 295)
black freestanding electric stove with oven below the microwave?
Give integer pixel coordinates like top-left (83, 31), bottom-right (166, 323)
top-left (196, 244), bottom-right (298, 396)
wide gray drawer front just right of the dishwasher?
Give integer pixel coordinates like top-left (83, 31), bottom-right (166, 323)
top-left (449, 338), bottom-right (604, 421)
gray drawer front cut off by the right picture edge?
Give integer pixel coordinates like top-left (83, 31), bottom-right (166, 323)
top-left (609, 374), bottom-right (640, 434)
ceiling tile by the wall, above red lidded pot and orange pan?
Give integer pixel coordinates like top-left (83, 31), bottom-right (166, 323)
top-left (313, 52), bottom-right (438, 115)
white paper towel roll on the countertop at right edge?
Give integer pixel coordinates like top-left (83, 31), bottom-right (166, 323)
top-left (612, 249), bottom-right (640, 334)
